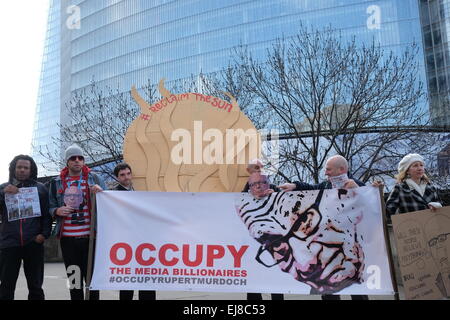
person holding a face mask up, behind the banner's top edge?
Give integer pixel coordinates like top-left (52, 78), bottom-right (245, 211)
top-left (242, 159), bottom-right (284, 300)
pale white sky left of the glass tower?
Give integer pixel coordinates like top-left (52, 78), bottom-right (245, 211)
top-left (0, 0), bottom-right (49, 183)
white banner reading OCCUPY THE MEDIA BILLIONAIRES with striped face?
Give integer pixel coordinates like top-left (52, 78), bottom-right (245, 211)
top-left (91, 187), bottom-right (394, 295)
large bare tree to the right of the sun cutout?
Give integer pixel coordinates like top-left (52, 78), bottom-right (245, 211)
top-left (203, 27), bottom-right (446, 183)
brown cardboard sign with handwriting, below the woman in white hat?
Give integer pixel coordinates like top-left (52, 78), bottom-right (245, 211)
top-left (392, 207), bottom-right (450, 300)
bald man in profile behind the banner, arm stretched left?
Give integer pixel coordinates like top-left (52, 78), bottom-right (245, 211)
top-left (279, 155), bottom-right (370, 300)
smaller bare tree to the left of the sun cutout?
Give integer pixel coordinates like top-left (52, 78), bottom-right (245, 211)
top-left (34, 81), bottom-right (156, 176)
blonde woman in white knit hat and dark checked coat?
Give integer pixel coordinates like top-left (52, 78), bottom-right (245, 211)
top-left (386, 153), bottom-right (442, 215)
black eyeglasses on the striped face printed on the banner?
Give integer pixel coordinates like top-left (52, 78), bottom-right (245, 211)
top-left (256, 190), bottom-right (323, 268)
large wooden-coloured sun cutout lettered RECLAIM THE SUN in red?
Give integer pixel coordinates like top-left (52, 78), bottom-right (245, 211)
top-left (123, 80), bottom-right (261, 192)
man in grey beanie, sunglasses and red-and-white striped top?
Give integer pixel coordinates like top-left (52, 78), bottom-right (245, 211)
top-left (49, 145), bottom-right (105, 300)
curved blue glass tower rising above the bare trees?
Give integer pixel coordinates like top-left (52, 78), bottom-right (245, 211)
top-left (33, 0), bottom-right (450, 174)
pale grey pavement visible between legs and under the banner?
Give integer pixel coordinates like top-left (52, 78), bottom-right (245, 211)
top-left (11, 263), bottom-right (403, 300)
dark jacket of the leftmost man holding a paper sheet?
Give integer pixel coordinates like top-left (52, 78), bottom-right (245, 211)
top-left (0, 180), bottom-right (52, 249)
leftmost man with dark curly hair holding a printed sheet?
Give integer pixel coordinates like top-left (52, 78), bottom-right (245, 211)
top-left (0, 155), bottom-right (52, 300)
